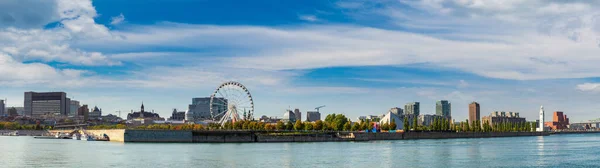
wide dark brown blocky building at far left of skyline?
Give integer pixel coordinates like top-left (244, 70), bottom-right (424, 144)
top-left (24, 92), bottom-right (71, 116)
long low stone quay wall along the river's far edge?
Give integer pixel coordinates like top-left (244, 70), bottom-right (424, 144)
top-left (62, 129), bottom-right (550, 143)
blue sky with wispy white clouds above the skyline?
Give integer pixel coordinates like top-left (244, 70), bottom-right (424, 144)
top-left (0, 0), bottom-right (600, 122)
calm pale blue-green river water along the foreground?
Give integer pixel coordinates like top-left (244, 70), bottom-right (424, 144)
top-left (0, 134), bottom-right (600, 168)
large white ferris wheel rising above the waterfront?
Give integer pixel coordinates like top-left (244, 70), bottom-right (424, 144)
top-left (210, 81), bottom-right (254, 125)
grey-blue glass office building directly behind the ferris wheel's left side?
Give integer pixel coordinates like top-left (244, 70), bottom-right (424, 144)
top-left (188, 97), bottom-right (227, 120)
